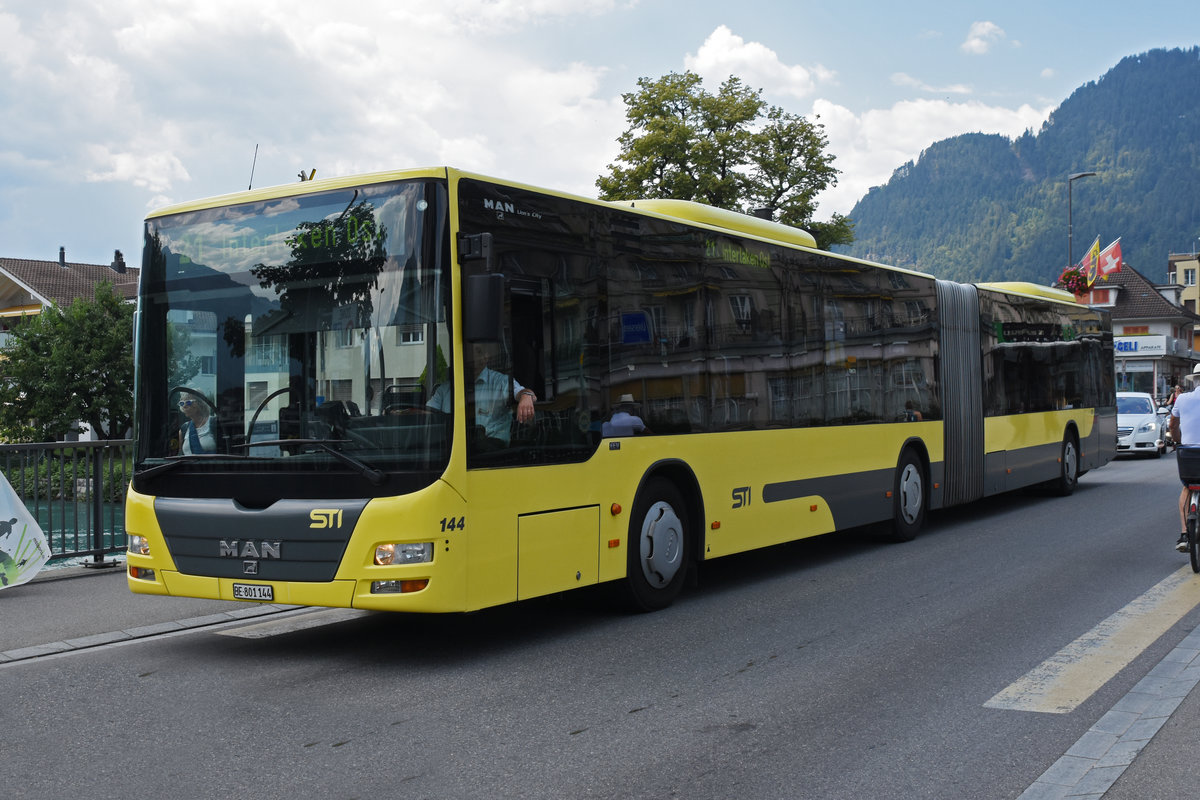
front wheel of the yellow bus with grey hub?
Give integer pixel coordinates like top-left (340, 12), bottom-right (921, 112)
top-left (625, 477), bottom-right (691, 612)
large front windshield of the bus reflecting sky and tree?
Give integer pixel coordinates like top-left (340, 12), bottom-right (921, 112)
top-left (137, 181), bottom-right (451, 493)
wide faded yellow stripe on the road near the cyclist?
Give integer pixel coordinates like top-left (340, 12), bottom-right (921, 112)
top-left (984, 566), bottom-right (1200, 714)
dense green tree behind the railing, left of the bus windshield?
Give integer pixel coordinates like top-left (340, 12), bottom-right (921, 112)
top-left (0, 283), bottom-right (133, 441)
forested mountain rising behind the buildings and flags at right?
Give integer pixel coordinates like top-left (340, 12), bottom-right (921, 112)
top-left (836, 47), bottom-right (1200, 284)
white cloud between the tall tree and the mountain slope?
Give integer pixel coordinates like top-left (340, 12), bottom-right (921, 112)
top-left (812, 100), bottom-right (1052, 218)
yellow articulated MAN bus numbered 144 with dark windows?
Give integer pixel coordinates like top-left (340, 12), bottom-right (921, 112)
top-left (126, 168), bottom-right (1116, 612)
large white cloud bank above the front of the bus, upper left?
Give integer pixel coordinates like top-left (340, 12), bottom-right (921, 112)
top-left (0, 0), bottom-right (629, 206)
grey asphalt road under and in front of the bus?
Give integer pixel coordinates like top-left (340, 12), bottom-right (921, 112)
top-left (0, 458), bottom-right (1200, 799)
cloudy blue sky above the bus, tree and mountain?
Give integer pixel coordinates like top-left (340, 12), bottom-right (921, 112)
top-left (0, 0), bottom-right (1200, 264)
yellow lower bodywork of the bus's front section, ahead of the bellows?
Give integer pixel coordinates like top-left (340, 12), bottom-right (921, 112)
top-left (126, 421), bottom-right (955, 612)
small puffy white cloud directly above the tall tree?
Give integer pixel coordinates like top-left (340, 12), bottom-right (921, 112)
top-left (684, 25), bottom-right (834, 97)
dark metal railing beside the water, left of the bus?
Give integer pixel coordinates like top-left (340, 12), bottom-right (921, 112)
top-left (0, 439), bottom-right (133, 566)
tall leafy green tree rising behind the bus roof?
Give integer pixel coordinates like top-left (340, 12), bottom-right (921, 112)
top-left (596, 71), bottom-right (854, 247)
